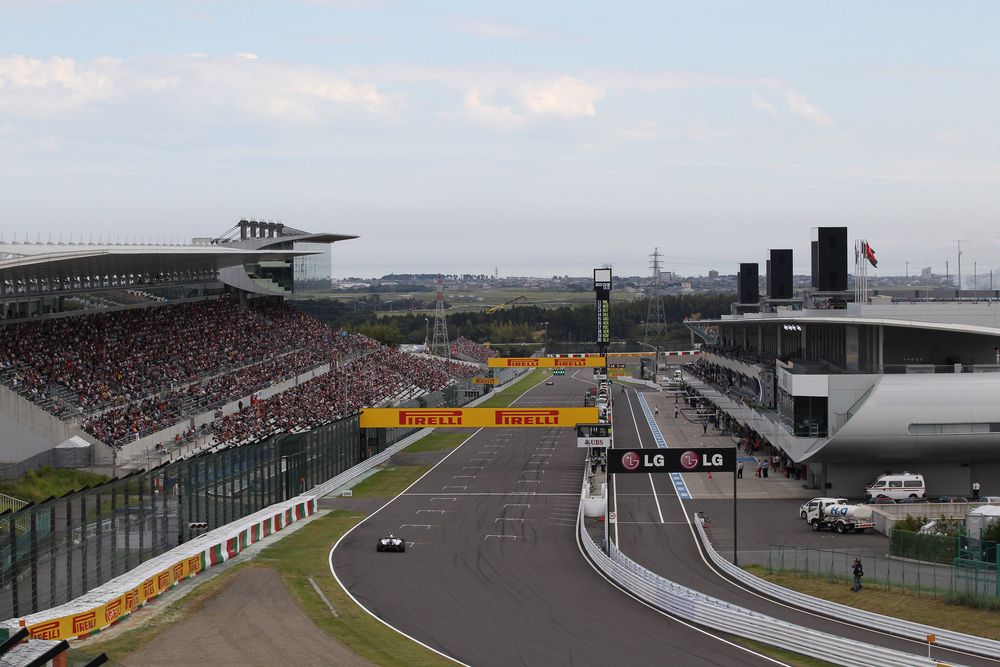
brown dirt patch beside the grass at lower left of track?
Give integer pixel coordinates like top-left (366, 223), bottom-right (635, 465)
top-left (124, 567), bottom-right (372, 667)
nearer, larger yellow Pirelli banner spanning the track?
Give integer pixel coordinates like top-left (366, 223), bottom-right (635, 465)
top-left (361, 408), bottom-right (598, 428)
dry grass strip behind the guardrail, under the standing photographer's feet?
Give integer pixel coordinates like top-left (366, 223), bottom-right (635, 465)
top-left (745, 565), bottom-right (1000, 640)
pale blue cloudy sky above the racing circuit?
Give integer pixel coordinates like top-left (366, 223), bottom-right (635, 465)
top-left (0, 0), bottom-right (1000, 276)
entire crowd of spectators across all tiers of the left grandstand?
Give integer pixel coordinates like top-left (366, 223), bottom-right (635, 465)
top-left (0, 300), bottom-right (481, 446)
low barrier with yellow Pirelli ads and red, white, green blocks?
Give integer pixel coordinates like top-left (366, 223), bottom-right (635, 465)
top-left (0, 495), bottom-right (318, 640)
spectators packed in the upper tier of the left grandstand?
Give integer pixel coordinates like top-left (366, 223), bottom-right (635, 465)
top-left (0, 300), bottom-right (329, 414)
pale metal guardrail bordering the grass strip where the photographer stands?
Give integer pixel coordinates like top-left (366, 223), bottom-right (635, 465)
top-left (695, 516), bottom-right (1000, 660)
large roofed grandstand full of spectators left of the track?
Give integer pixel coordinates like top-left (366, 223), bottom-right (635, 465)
top-left (0, 220), bottom-right (476, 474)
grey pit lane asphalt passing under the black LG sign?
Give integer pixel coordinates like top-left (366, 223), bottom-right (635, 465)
top-left (612, 388), bottom-right (1000, 667)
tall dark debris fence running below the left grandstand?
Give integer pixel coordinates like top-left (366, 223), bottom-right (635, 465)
top-left (0, 373), bottom-right (500, 619)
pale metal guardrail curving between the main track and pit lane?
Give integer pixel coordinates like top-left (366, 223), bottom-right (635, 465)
top-left (579, 508), bottom-right (956, 667)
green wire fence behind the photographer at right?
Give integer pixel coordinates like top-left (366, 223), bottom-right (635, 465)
top-left (767, 544), bottom-right (1000, 606)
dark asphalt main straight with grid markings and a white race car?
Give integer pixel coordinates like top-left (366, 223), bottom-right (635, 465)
top-left (330, 376), bottom-right (780, 666)
